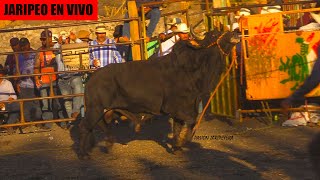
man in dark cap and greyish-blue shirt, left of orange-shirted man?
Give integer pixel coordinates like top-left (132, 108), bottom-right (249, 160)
top-left (17, 38), bottom-right (42, 121)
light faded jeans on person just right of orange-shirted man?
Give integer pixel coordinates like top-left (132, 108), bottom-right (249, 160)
top-left (58, 75), bottom-right (84, 118)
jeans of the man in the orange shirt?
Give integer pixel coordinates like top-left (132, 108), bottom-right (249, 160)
top-left (40, 81), bottom-right (64, 128)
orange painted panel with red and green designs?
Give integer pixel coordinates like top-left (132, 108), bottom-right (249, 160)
top-left (242, 13), bottom-right (320, 100)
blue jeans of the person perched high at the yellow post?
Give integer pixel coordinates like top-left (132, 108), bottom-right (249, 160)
top-left (122, 8), bottom-right (161, 39)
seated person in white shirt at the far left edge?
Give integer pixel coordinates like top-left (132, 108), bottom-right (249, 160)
top-left (0, 65), bottom-right (20, 124)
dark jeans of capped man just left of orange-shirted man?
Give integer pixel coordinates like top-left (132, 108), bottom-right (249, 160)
top-left (19, 87), bottom-right (42, 122)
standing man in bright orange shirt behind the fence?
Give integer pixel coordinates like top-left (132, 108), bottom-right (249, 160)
top-left (34, 30), bottom-right (64, 129)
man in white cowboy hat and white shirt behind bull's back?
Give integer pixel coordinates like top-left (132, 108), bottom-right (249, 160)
top-left (158, 18), bottom-right (182, 57)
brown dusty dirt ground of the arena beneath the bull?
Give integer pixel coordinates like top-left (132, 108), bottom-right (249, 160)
top-left (0, 116), bottom-right (320, 179)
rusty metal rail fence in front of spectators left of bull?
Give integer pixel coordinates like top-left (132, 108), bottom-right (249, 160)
top-left (0, 0), bottom-right (202, 128)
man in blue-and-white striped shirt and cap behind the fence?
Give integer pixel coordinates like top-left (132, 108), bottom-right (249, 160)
top-left (89, 26), bottom-right (122, 68)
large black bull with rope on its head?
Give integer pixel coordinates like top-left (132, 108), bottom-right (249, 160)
top-left (79, 31), bottom-right (238, 158)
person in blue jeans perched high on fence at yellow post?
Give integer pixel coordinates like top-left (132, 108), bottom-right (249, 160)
top-left (122, 0), bottom-right (162, 42)
